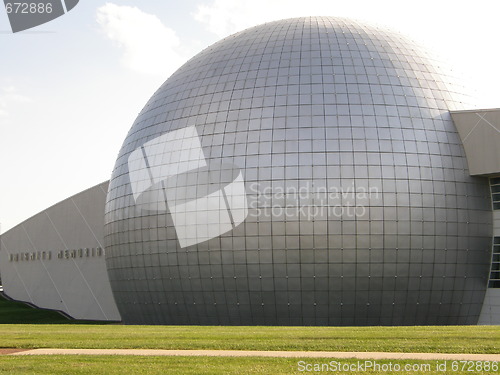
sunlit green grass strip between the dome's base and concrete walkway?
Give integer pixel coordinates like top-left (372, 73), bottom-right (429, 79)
top-left (0, 324), bottom-right (500, 353)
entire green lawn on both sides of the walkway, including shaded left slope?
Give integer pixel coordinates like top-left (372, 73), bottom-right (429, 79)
top-left (0, 298), bottom-right (500, 375)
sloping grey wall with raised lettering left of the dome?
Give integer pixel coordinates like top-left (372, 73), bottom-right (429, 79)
top-left (0, 181), bottom-right (121, 321)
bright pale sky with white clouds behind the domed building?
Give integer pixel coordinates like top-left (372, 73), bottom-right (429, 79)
top-left (0, 0), bottom-right (500, 233)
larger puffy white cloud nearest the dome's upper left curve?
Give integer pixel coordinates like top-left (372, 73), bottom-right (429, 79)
top-left (97, 3), bottom-right (185, 76)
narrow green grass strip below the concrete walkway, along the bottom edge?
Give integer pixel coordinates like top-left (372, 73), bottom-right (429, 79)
top-left (0, 356), bottom-right (499, 375)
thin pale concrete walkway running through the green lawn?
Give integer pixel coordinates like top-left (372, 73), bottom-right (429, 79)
top-left (9, 349), bottom-right (500, 362)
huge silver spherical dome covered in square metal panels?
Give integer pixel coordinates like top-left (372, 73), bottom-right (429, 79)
top-left (105, 17), bottom-right (492, 325)
